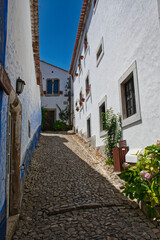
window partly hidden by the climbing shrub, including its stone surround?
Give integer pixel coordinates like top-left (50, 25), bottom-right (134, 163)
top-left (98, 96), bottom-right (107, 137)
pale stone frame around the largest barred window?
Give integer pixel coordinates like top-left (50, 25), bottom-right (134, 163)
top-left (118, 61), bottom-right (141, 127)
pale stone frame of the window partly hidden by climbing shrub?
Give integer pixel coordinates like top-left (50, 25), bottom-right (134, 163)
top-left (98, 95), bottom-right (107, 137)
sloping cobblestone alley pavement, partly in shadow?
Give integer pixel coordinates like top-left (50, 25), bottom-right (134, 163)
top-left (13, 133), bottom-right (160, 240)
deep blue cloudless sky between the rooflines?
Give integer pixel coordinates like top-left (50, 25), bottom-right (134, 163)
top-left (39, 0), bottom-right (83, 70)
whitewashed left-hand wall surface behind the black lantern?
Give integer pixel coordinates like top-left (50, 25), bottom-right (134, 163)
top-left (5, 0), bottom-right (41, 159)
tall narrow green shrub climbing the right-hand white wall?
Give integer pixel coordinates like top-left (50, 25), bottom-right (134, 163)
top-left (102, 108), bottom-right (121, 164)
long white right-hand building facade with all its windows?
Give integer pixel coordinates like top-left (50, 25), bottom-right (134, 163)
top-left (69, 0), bottom-right (160, 156)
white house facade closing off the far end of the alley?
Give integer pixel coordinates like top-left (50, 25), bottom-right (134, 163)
top-left (40, 61), bottom-right (71, 130)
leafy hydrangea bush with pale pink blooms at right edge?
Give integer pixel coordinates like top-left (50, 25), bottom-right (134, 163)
top-left (120, 145), bottom-right (160, 218)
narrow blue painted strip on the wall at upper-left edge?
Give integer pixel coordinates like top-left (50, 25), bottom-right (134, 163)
top-left (0, 0), bottom-right (8, 67)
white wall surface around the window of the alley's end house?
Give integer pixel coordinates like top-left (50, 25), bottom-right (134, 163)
top-left (40, 61), bottom-right (70, 120)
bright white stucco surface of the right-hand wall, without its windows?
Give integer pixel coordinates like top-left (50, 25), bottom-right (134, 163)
top-left (74, 0), bottom-right (160, 148)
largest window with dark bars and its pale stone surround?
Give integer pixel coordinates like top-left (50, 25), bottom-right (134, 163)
top-left (119, 62), bottom-right (141, 127)
